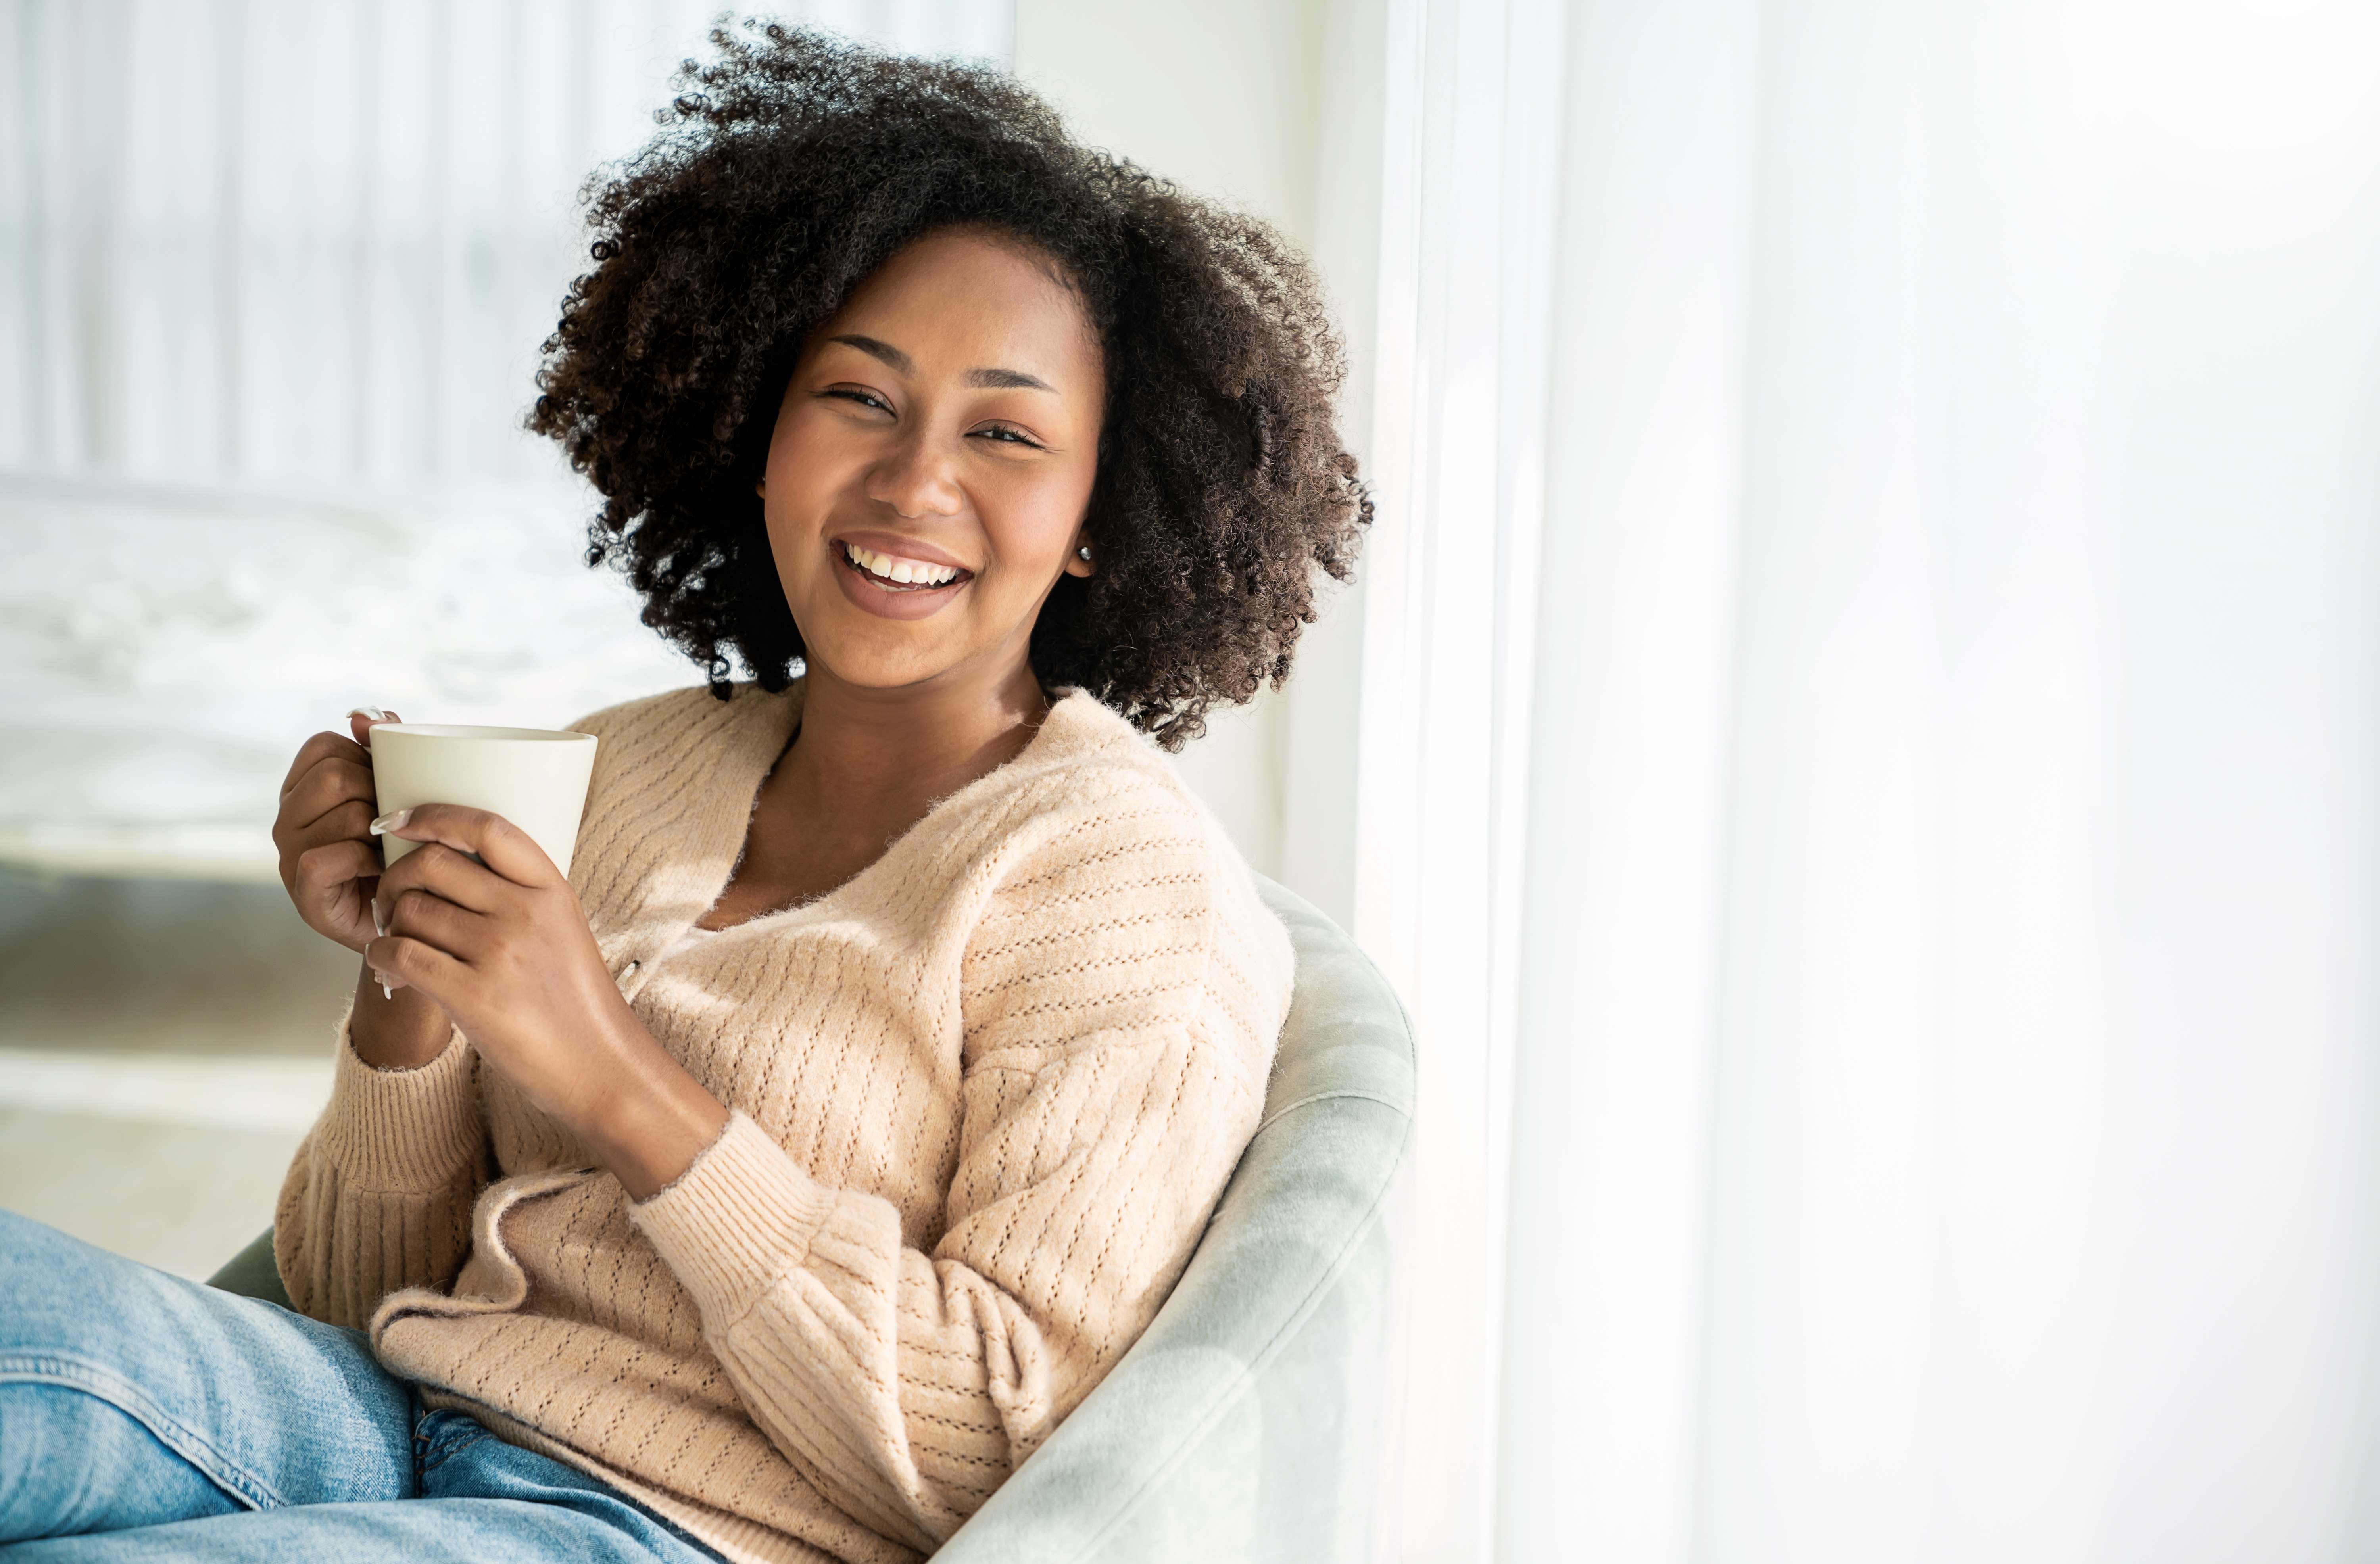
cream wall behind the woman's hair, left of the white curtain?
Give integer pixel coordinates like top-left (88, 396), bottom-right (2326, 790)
top-left (1016, 0), bottom-right (1371, 914)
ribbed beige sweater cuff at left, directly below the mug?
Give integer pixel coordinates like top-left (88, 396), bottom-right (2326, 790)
top-left (314, 1017), bottom-right (488, 1193)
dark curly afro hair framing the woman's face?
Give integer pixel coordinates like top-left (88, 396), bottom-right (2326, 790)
top-left (528, 21), bottom-right (1371, 747)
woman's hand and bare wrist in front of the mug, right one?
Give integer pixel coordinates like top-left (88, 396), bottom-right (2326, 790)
top-left (364, 805), bottom-right (728, 1200)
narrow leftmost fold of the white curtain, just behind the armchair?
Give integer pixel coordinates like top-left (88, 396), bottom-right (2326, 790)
top-left (1354, 0), bottom-right (1561, 1557)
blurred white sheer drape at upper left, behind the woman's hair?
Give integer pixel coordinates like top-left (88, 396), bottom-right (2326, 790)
top-left (0, 0), bottom-right (1012, 486)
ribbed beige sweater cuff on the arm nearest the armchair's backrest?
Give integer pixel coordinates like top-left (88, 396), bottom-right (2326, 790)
top-left (628, 1109), bottom-right (836, 1328)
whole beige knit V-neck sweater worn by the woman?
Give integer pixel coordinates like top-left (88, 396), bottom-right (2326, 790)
top-left (274, 685), bottom-right (1290, 1562)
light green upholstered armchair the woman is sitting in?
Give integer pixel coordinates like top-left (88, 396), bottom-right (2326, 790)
top-left (214, 881), bottom-right (1414, 1564)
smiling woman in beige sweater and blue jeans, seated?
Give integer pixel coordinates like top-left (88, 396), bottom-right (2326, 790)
top-left (0, 29), bottom-right (1368, 1564)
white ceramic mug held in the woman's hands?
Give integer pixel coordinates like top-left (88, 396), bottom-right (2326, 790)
top-left (371, 721), bottom-right (595, 874)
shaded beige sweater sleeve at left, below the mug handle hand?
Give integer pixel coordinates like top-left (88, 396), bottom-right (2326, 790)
top-left (274, 1017), bottom-right (488, 1328)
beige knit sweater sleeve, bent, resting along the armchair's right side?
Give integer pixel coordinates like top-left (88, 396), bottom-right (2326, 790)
top-left (633, 785), bottom-right (1290, 1552)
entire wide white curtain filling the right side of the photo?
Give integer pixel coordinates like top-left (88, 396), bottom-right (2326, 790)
top-left (1356, 0), bottom-right (2380, 1564)
